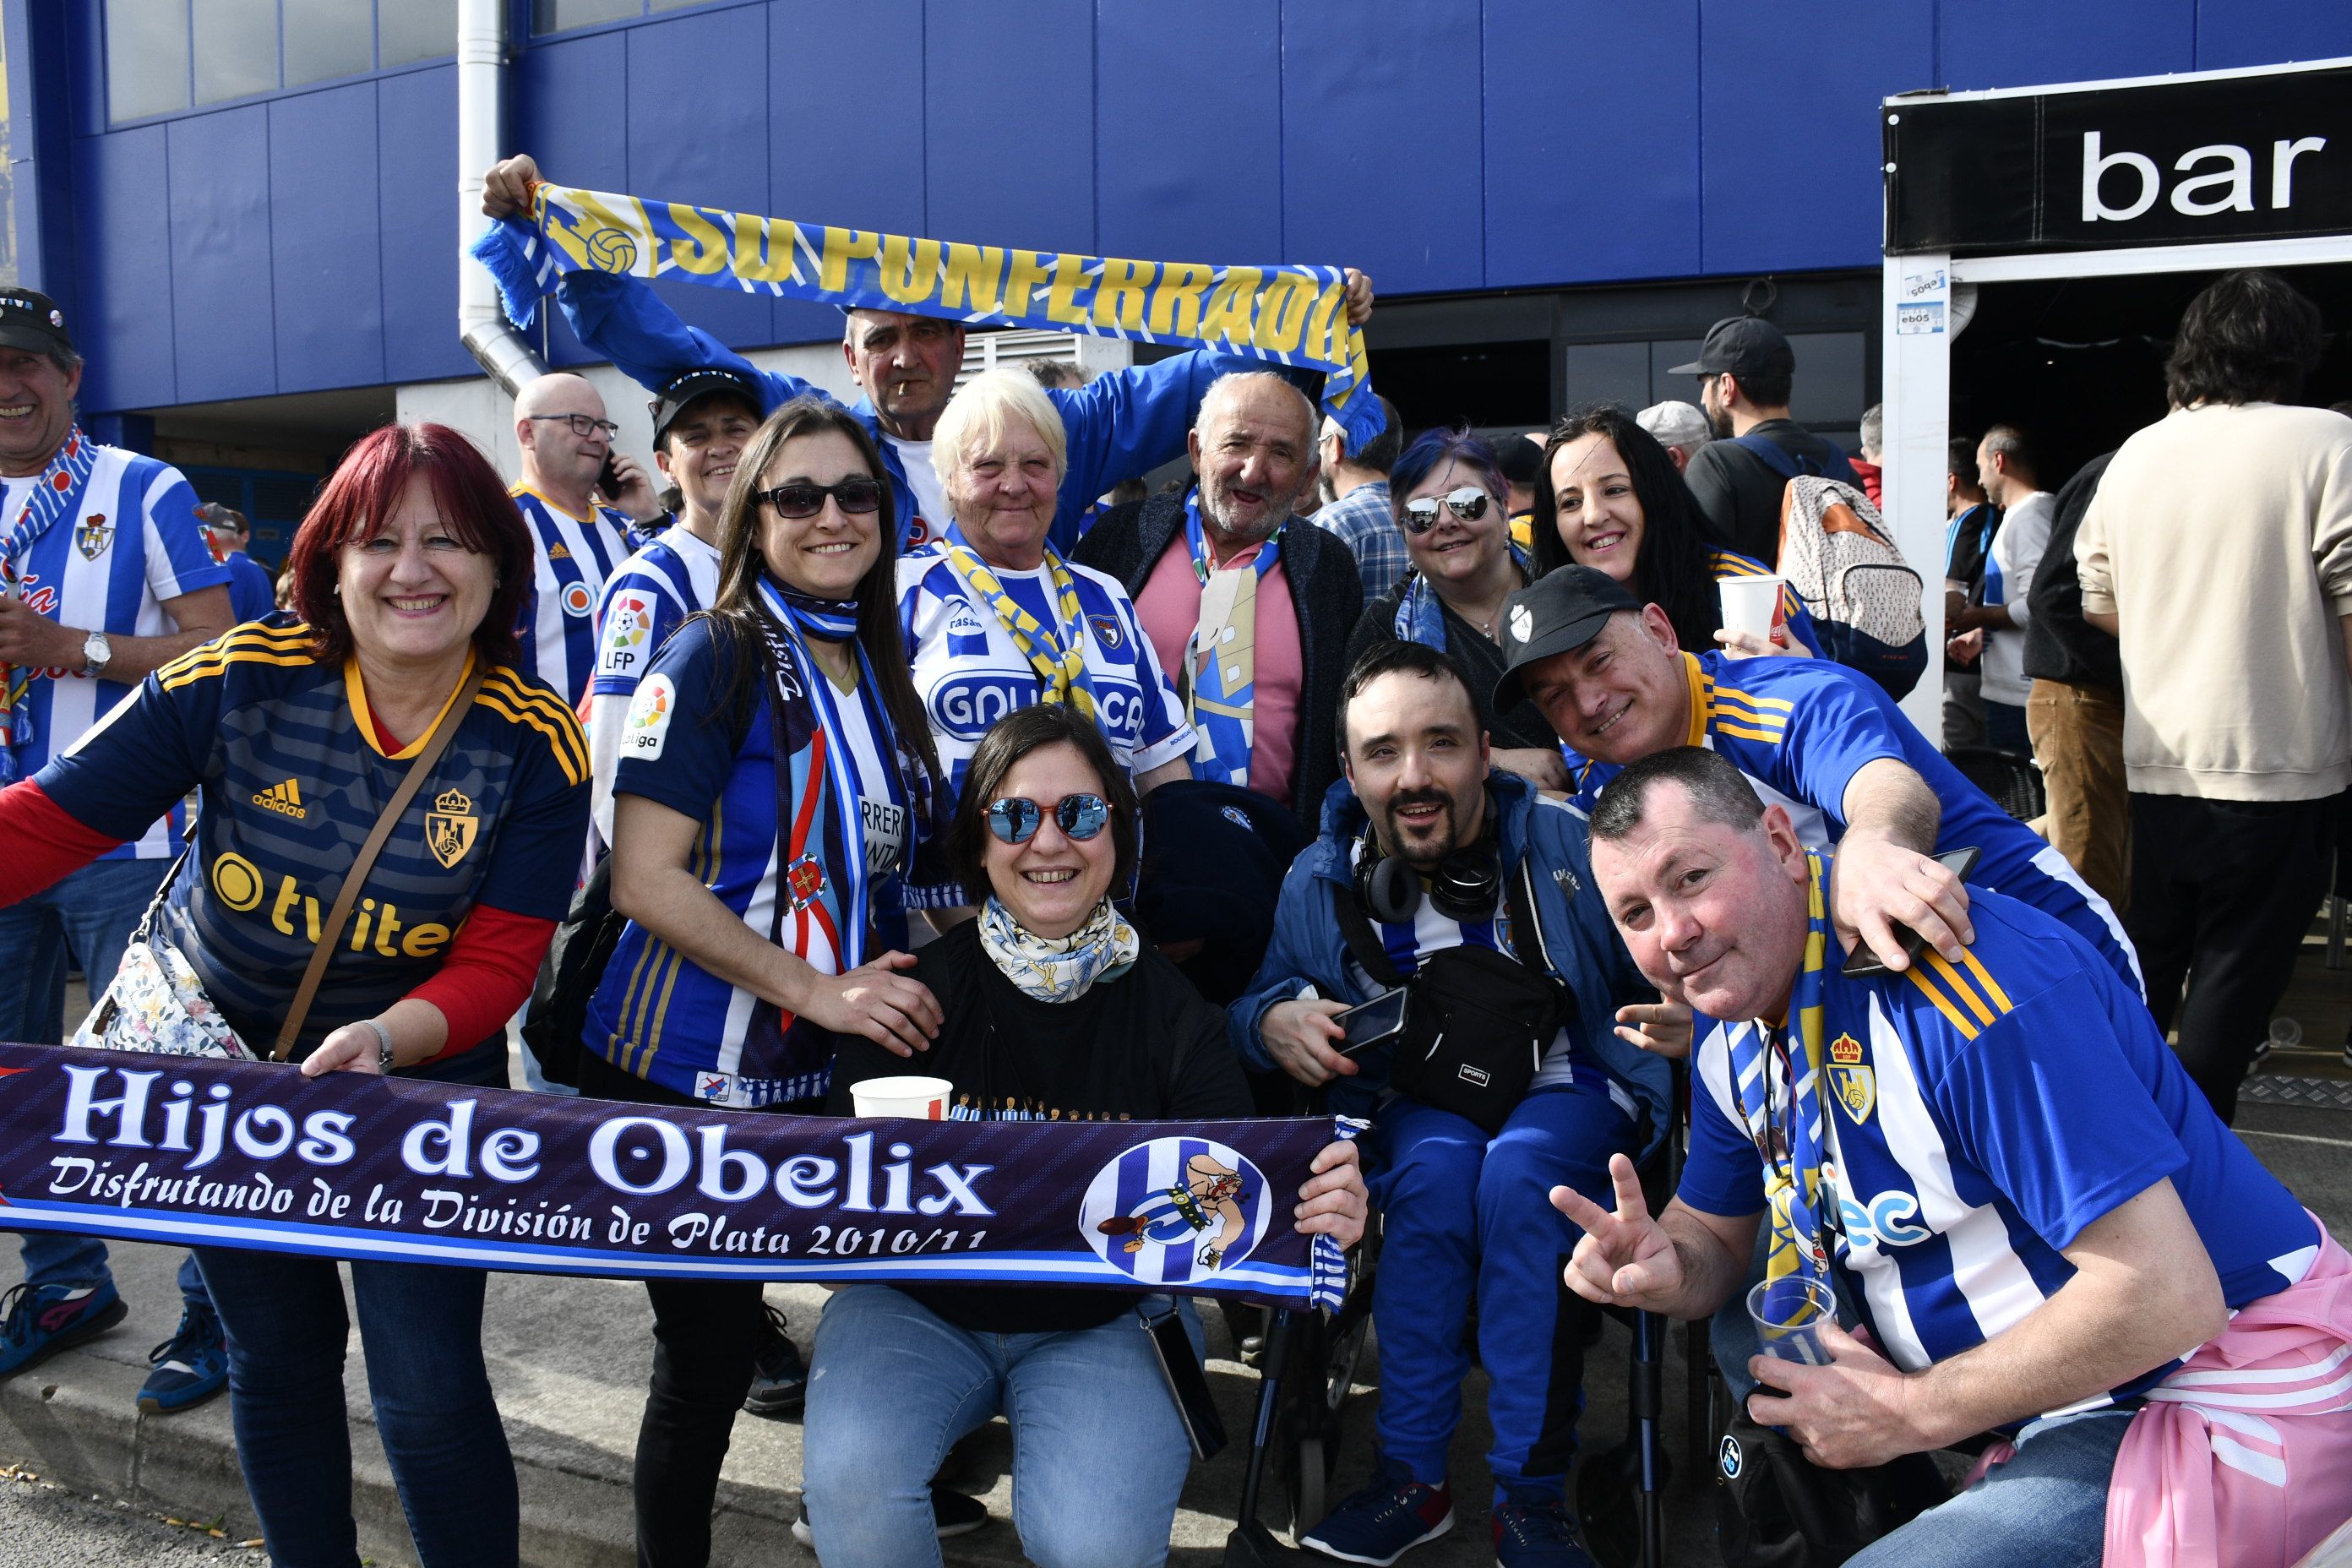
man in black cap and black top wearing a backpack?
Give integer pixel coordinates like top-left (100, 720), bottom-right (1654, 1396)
top-left (1668, 315), bottom-right (1860, 562)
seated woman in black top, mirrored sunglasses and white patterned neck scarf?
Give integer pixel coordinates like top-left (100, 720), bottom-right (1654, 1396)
top-left (804, 703), bottom-right (1367, 1568)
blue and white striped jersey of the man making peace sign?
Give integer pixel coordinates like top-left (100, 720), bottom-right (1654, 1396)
top-left (1682, 891), bottom-right (2319, 1403)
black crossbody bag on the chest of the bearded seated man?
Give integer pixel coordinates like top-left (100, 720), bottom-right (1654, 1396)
top-left (1331, 860), bottom-right (1576, 1138)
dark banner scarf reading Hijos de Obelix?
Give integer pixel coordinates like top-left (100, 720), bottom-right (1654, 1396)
top-left (0, 1043), bottom-right (1353, 1307)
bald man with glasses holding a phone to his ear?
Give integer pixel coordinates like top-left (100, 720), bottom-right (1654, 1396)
top-left (513, 373), bottom-right (661, 708)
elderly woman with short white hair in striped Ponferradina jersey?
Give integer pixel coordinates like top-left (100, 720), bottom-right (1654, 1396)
top-left (898, 372), bottom-right (1192, 914)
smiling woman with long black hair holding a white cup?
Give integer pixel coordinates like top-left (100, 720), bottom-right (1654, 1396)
top-left (1536, 402), bottom-right (1821, 658)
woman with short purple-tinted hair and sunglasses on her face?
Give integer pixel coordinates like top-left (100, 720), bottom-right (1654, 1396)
top-left (1345, 427), bottom-right (1569, 790)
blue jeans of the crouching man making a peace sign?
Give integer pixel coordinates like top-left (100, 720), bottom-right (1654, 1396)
top-left (1846, 1411), bottom-right (2131, 1568)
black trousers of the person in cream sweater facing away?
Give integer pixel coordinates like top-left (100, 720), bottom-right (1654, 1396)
top-left (2124, 792), bottom-right (2336, 1121)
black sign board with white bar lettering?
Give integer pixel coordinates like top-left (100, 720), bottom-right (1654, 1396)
top-left (1881, 66), bottom-right (2352, 256)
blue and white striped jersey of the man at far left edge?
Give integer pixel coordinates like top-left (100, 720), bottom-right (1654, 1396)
top-left (0, 444), bottom-right (228, 860)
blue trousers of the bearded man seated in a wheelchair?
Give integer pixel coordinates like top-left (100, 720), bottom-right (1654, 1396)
top-left (1371, 1084), bottom-right (1635, 1502)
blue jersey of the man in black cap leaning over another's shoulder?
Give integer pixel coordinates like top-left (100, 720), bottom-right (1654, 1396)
top-left (1560, 654), bottom-right (2145, 989)
